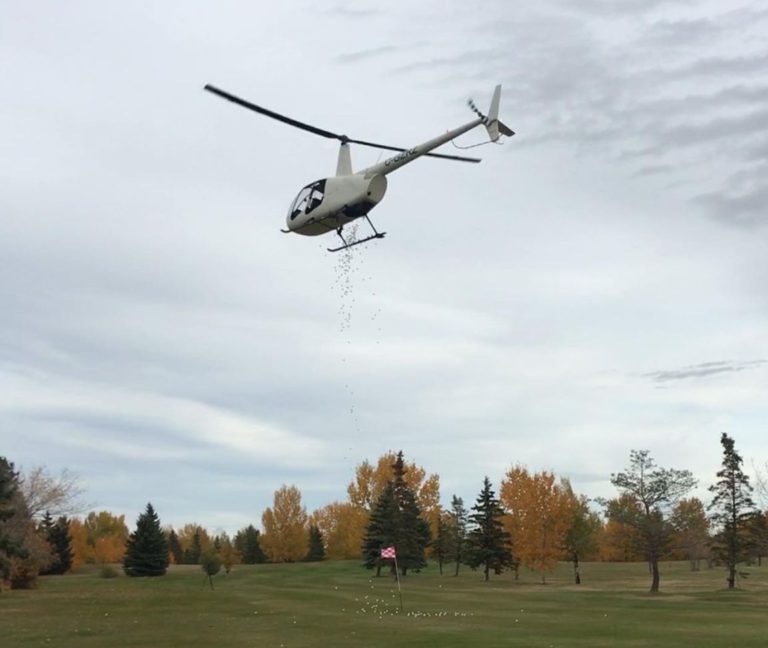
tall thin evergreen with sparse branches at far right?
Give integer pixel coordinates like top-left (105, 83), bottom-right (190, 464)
top-left (708, 432), bottom-right (755, 589)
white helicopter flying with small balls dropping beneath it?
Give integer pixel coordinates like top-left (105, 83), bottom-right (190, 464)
top-left (205, 84), bottom-right (515, 252)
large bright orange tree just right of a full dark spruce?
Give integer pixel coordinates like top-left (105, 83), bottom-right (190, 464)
top-left (500, 466), bottom-right (572, 583)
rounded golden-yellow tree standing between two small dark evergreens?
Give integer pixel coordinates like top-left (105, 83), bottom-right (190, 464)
top-left (261, 485), bottom-right (309, 562)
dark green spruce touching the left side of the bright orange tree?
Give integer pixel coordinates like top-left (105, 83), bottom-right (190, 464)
top-left (467, 477), bottom-right (512, 581)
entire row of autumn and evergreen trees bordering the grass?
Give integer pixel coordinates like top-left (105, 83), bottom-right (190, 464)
top-left (0, 434), bottom-right (768, 591)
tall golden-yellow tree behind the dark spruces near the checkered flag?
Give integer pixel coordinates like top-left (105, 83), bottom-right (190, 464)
top-left (347, 452), bottom-right (441, 556)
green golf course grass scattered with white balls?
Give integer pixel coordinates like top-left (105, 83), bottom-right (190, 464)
top-left (0, 562), bottom-right (768, 648)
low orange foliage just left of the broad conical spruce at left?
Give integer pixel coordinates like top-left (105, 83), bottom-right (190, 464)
top-left (69, 511), bottom-right (128, 570)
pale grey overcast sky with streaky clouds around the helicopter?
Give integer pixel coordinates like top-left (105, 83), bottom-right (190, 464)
top-left (0, 0), bottom-right (768, 531)
